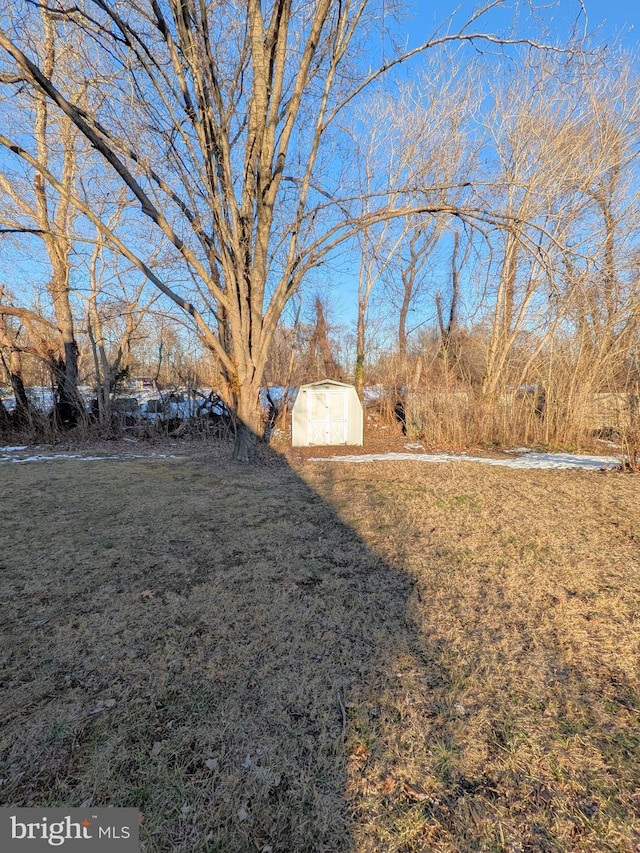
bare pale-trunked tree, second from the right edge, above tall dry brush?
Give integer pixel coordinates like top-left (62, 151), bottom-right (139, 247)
top-left (472, 57), bottom-right (587, 396)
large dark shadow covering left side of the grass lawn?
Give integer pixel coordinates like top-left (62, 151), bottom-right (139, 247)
top-left (0, 442), bottom-right (456, 853)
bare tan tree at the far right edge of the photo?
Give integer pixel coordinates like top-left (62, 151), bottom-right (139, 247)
top-left (558, 57), bottom-right (640, 442)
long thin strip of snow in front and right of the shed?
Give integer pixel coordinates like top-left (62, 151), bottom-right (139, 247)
top-left (309, 451), bottom-right (620, 470)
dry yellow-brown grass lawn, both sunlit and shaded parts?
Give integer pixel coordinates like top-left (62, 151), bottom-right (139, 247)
top-left (0, 446), bottom-right (640, 853)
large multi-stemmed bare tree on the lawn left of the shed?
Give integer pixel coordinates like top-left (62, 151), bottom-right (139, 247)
top-left (0, 0), bottom-right (580, 461)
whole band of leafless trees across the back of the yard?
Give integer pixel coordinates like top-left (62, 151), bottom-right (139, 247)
top-left (0, 0), bottom-right (640, 461)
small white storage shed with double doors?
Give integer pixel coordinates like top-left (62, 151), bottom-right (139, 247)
top-left (291, 379), bottom-right (363, 447)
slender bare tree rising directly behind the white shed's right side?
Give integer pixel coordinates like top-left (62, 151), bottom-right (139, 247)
top-left (354, 55), bottom-right (479, 392)
